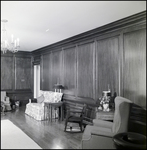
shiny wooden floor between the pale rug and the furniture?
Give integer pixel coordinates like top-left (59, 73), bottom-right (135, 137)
top-left (1, 106), bottom-right (83, 149)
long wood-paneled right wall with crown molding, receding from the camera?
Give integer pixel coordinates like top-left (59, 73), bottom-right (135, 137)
top-left (32, 11), bottom-right (146, 133)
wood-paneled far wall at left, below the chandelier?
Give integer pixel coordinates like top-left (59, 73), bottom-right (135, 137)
top-left (1, 52), bottom-right (33, 105)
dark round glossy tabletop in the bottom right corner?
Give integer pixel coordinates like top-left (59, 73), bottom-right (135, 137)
top-left (113, 132), bottom-right (146, 149)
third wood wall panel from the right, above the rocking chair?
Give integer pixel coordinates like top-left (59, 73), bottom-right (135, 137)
top-left (77, 42), bottom-right (95, 98)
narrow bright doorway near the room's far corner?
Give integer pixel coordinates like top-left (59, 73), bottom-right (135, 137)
top-left (34, 65), bottom-right (40, 98)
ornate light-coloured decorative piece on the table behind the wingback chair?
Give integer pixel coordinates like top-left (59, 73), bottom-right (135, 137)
top-left (98, 90), bottom-right (111, 111)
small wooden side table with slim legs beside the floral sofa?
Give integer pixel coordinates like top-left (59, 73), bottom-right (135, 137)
top-left (44, 102), bottom-right (64, 122)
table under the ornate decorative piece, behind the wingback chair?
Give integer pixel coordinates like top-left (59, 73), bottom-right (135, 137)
top-left (96, 109), bottom-right (114, 121)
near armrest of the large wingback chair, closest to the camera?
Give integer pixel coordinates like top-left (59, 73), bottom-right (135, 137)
top-left (91, 129), bottom-right (115, 138)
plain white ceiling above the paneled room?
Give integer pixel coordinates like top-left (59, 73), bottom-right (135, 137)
top-left (1, 1), bottom-right (146, 51)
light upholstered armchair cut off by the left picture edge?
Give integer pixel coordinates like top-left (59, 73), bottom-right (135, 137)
top-left (1, 91), bottom-right (11, 111)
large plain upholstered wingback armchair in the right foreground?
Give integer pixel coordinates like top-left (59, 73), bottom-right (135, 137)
top-left (81, 96), bottom-right (132, 149)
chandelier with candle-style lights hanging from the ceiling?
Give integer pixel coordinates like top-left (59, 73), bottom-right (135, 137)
top-left (1, 19), bottom-right (20, 54)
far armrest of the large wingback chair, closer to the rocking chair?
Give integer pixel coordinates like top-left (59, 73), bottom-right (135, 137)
top-left (93, 119), bottom-right (113, 129)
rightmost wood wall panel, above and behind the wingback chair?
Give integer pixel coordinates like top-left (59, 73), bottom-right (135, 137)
top-left (123, 29), bottom-right (146, 107)
